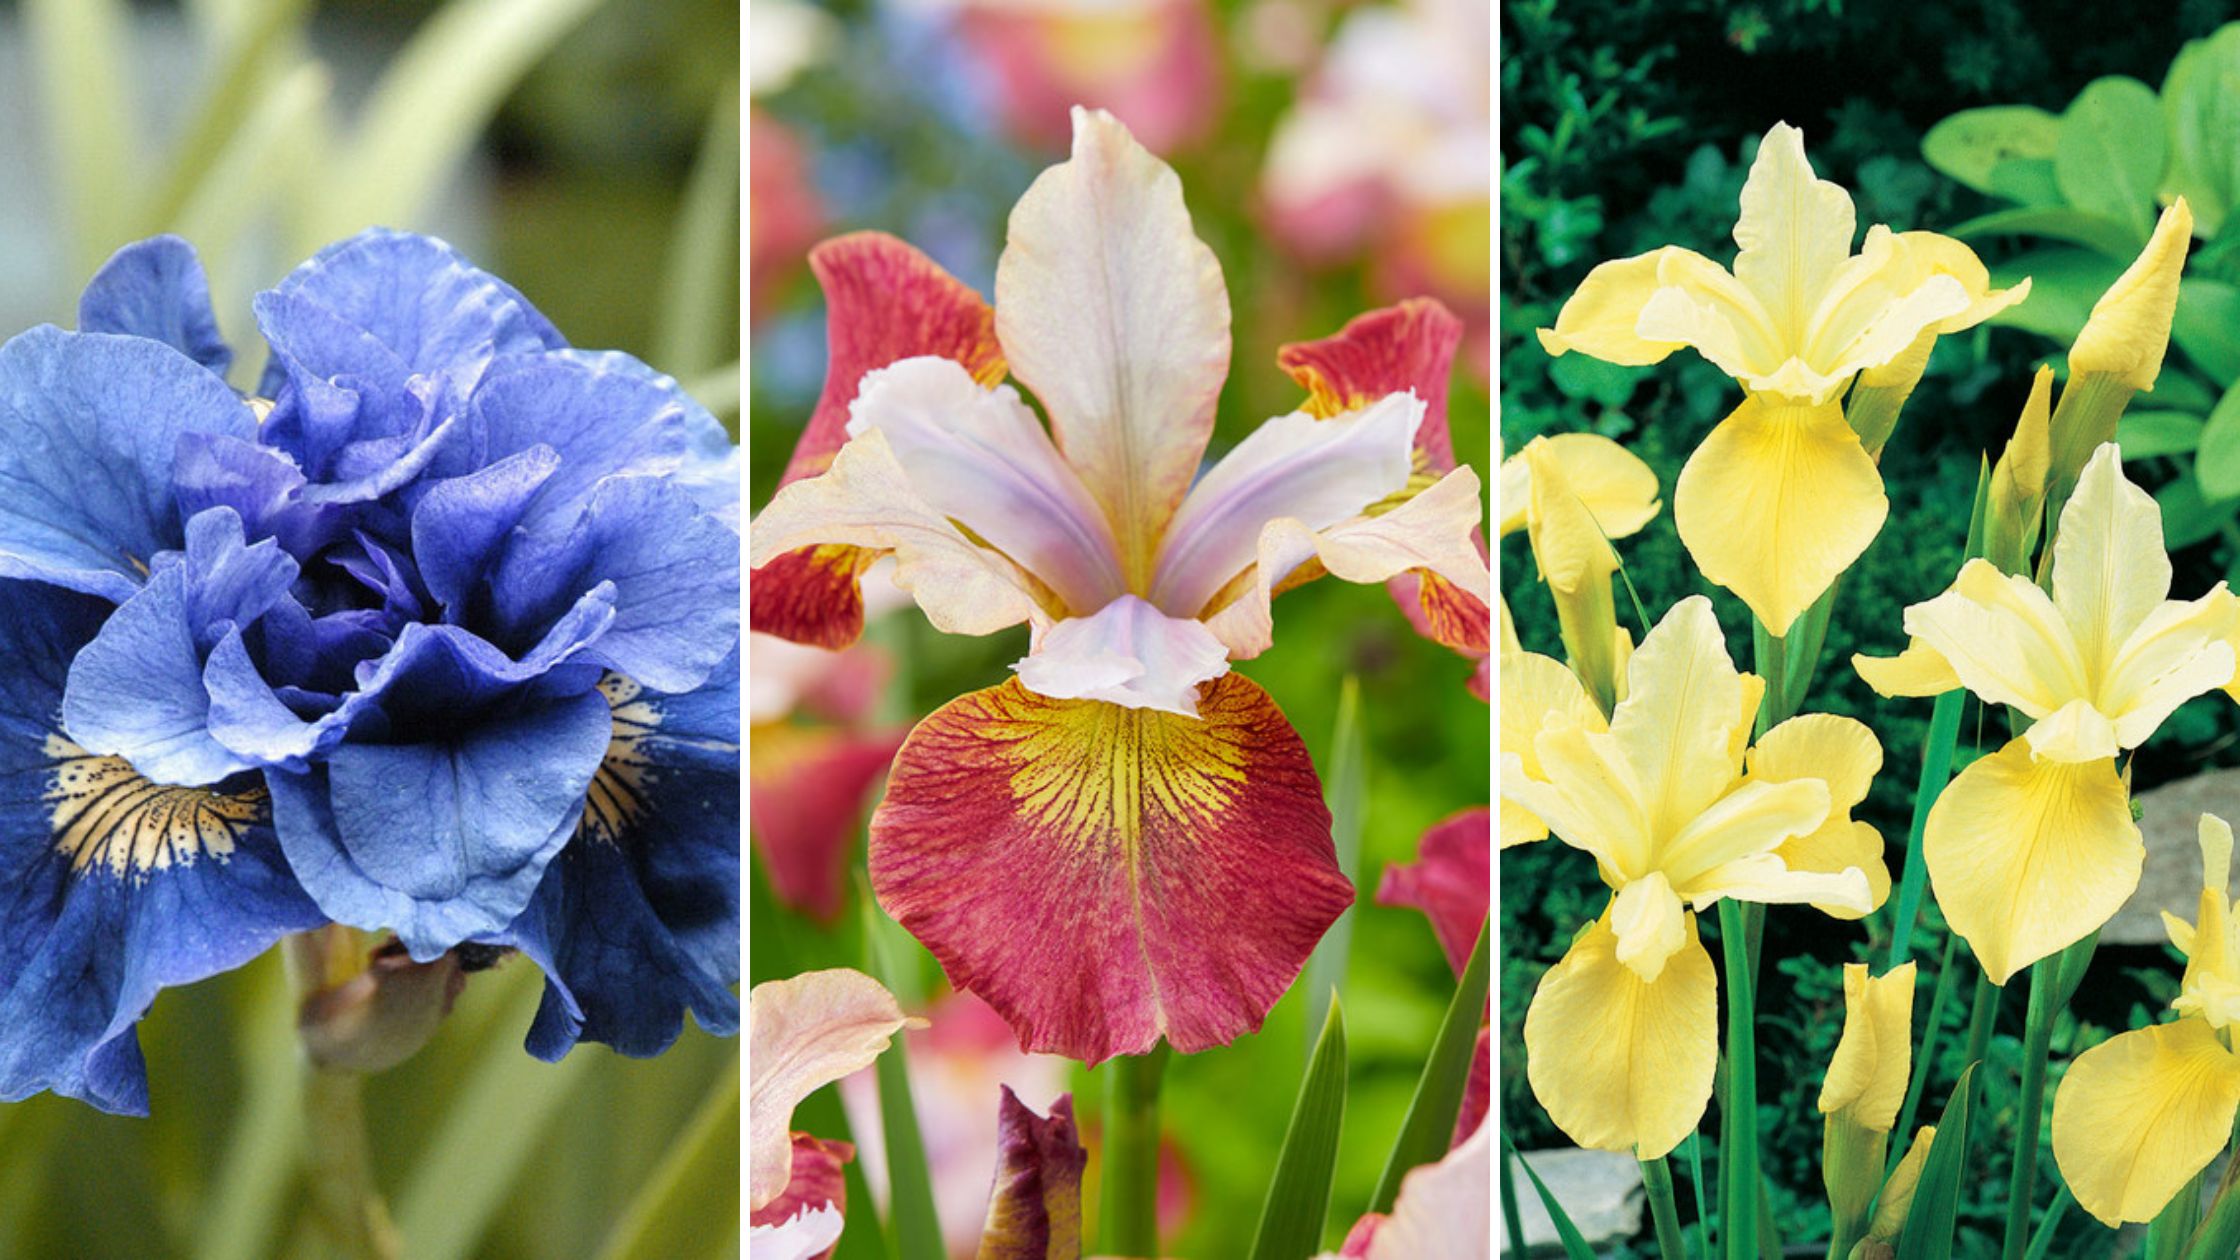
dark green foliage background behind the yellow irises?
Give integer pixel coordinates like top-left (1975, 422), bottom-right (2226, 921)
top-left (1499, 0), bottom-right (2240, 1256)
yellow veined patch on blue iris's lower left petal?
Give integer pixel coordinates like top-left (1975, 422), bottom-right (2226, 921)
top-left (45, 733), bottom-right (267, 877)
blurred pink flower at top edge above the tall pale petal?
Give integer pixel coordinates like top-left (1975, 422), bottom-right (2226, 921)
top-left (900, 0), bottom-right (1221, 152)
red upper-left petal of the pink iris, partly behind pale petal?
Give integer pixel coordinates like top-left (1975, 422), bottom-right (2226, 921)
top-left (748, 231), bottom-right (1004, 648)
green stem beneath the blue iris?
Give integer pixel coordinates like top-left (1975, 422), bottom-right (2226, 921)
top-left (280, 926), bottom-right (403, 1260)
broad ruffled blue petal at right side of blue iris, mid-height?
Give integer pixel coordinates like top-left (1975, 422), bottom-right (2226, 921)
top-left (491, 478), bottom-right (739, 693)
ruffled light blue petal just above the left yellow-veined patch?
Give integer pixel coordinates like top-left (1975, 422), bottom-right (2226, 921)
top-left (63, 507), bottom-right (296, 785)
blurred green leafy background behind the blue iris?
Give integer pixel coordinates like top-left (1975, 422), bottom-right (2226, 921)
top-left (0, 0), bottom-right (739, 1260)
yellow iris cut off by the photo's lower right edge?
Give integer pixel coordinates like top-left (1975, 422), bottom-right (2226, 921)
top-left (2054, 814), bottom-right (2240, 1226)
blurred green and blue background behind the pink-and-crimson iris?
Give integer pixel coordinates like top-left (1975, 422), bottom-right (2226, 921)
top-left (746, 0), bottom-right (1492, 1260)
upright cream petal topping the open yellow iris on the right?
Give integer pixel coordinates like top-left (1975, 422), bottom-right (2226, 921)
top-left (2052, 442), bottom-right (2171, 675)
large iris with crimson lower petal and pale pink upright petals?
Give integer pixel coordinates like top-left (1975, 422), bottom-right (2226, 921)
top-left (748, 110), bottom-right (1492, 1063)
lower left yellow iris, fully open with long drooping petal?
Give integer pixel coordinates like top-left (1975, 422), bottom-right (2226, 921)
top-left (1501, 596), bottom-right (1888, 1159)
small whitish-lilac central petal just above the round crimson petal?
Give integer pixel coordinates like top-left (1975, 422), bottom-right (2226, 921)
top-left (1010, 594), bottom-right (1230, 717)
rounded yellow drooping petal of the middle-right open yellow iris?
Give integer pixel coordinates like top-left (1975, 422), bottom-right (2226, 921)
top-left (1922, 740), bottom-right (2146, 984)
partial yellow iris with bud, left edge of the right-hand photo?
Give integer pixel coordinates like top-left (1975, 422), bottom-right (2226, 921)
top-left (1501, 433), bottom-right (1658, 713)
